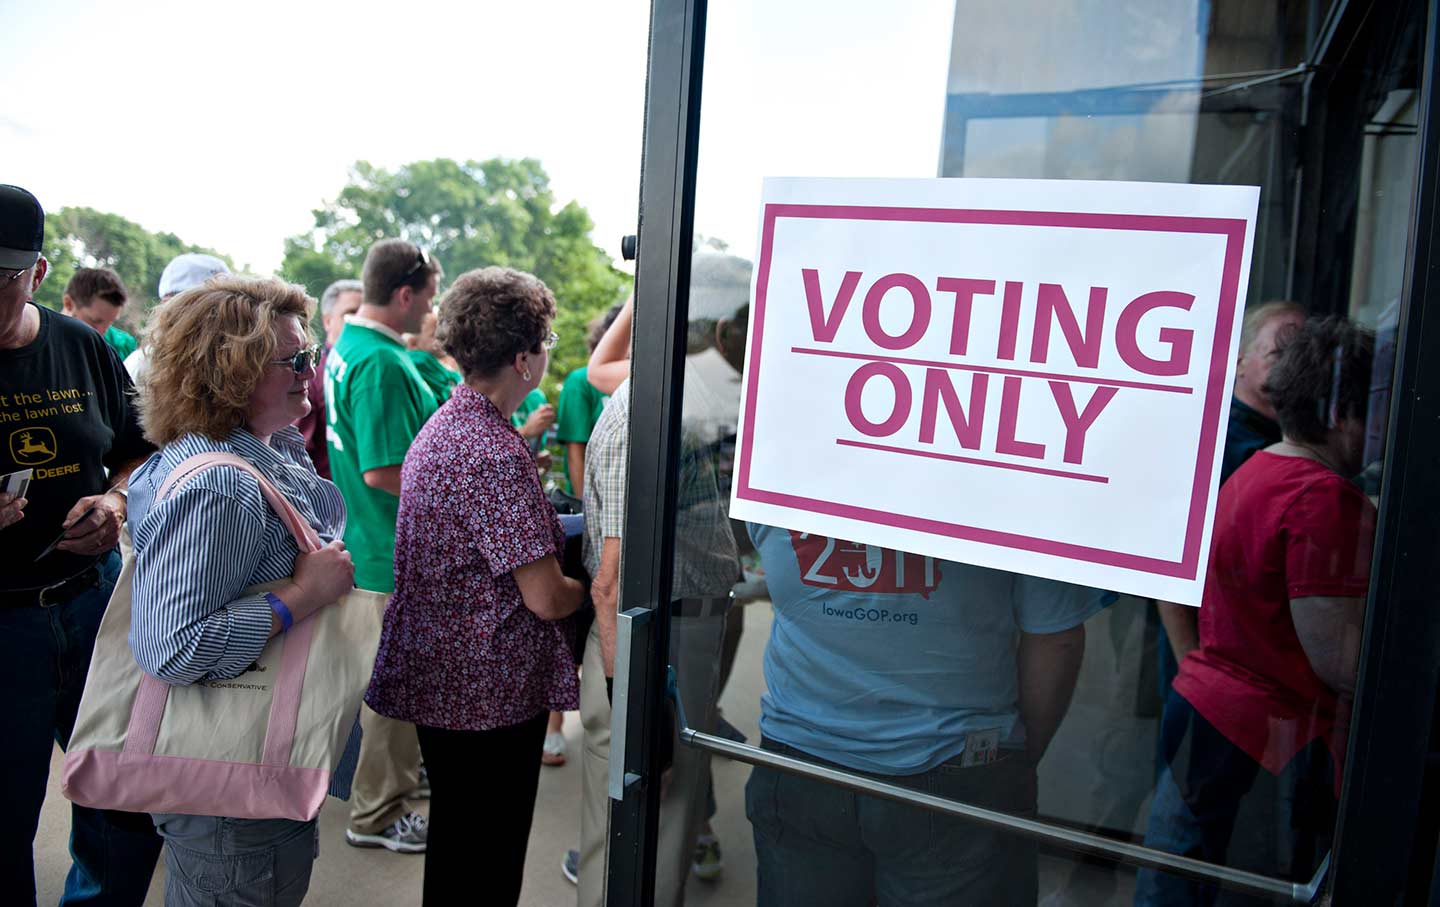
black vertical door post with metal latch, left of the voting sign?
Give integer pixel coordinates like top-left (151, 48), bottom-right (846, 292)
top-left (605, 0), bottom-right (706, 907)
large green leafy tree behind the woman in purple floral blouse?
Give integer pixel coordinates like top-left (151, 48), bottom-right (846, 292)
top-left (281, 158), bottom-right (631, 394)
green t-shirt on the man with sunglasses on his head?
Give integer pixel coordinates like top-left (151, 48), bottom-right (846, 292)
top-left (325, 322), bottom-right (441, 592)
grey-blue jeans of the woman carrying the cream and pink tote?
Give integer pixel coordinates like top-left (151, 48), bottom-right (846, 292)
top-left (151, 817), bottom-right (316, 907)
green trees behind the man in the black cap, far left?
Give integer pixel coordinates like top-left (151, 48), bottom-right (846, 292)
top-left (35, 207), bottom-right (233, 333)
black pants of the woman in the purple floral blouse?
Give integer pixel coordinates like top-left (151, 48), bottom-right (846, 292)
top-left (415, 711), bottom-right (549, 904)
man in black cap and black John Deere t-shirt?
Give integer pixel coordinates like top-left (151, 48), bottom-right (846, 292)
top-left (0, 186), bottom-right (160, 906)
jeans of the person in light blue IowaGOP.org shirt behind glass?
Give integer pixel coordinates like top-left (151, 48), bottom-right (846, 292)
top-left (744, 740), bottom-right (1038, 907)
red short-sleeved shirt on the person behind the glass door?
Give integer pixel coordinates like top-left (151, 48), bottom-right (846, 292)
top-left (1175, 451), bottom-right (1375, 775)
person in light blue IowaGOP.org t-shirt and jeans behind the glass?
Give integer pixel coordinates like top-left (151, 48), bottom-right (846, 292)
top-left (746, 524), bottom-right (1115, 904)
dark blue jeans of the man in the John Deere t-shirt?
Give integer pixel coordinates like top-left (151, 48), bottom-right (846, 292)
top-left (0, 551), bottom-right (160, 907)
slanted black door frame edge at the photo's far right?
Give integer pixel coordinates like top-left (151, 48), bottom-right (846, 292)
top-left (1333, 1), bottom-right (1440, 904)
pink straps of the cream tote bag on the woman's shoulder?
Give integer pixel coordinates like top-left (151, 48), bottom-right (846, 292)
top-left (124, 452), bottom-right (323, 767)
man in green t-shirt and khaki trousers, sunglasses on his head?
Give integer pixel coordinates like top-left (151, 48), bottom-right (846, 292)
top-left (325, 239), bottom-right (441, 854)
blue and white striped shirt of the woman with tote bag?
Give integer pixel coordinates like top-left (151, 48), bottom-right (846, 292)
top-left (128, 428), bottom-right (357, 796)
